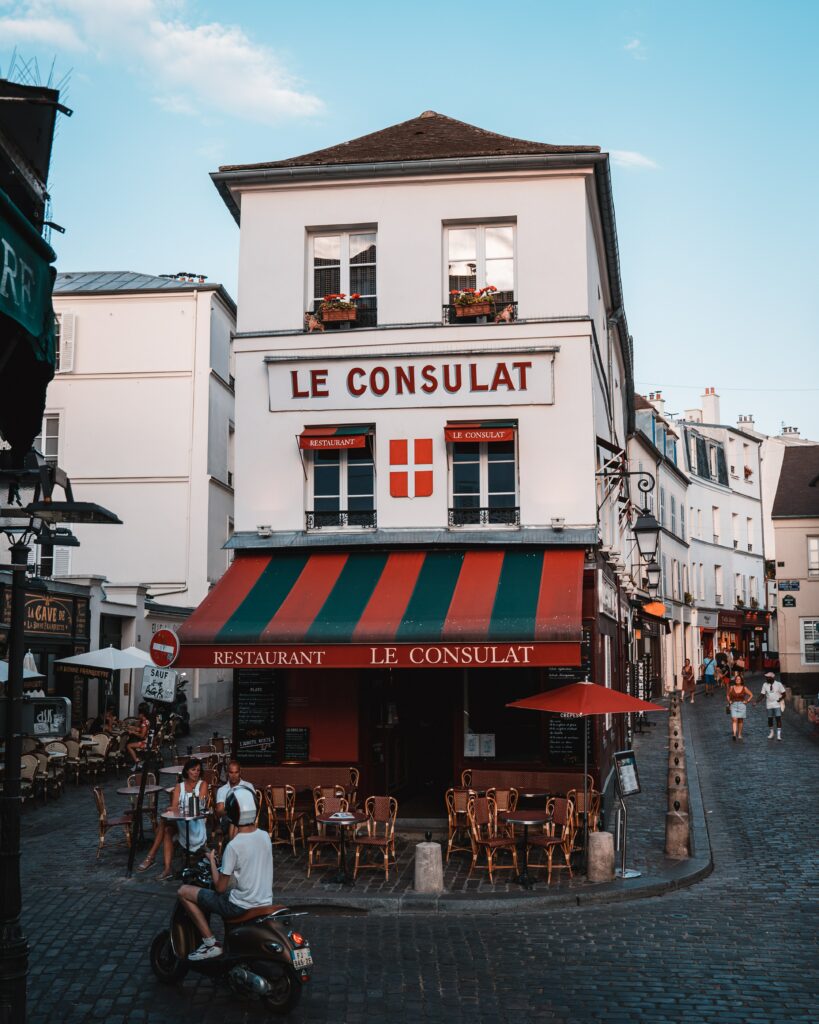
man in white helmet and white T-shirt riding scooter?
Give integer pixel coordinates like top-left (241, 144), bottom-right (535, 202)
top-left (178, 787), bottom-right (273, 961)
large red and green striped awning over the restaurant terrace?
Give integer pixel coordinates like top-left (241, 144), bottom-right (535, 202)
top-left (177, 549), bottom-right (584, 668)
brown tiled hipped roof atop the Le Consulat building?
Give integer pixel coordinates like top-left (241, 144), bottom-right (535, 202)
top-left (219, 111), bottom-right (600, 171)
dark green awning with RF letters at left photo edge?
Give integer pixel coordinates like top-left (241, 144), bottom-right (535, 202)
top-left (0, 189), bottom-right (56, 368)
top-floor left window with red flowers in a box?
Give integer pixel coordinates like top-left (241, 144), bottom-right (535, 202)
top-left (308, 229), bottom-right (378, 330)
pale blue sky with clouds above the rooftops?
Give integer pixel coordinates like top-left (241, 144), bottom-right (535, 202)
top-left (0, 0), bottom-right (819, 440)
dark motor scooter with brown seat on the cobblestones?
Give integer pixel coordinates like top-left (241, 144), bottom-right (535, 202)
top-left (150, 860), bottom-right (313, 1016)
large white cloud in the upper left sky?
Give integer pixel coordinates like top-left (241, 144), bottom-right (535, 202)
top-left (0, 0), bottom-right (324, 124)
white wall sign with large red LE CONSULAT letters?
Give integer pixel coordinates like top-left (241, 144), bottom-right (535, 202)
top-left (267, 352), bottom-right (554, 413)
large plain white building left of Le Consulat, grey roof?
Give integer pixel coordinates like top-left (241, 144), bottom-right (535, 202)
top-left (28, 272), bottom-right (235, 717)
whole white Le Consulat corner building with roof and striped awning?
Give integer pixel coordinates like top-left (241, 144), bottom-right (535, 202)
top-left (180, 111), bottom-right (634, 798)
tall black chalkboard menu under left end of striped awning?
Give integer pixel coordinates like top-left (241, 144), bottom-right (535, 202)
top-left (233, 669), bottom-right (282, 765)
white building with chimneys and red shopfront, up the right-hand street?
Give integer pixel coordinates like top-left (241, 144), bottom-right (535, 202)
top-left (678, 388), bottom-right (771, 668)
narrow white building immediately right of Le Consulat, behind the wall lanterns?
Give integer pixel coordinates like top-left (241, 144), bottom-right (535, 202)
top-left (629, 391), bottom-right (698, 691)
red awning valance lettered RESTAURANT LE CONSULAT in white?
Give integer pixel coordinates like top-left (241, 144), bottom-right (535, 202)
top-left (186, 642), bottom-right (580, 669)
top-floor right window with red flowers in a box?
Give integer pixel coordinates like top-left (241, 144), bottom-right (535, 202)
top-left (444, 223), bottom-right (517, 323)
